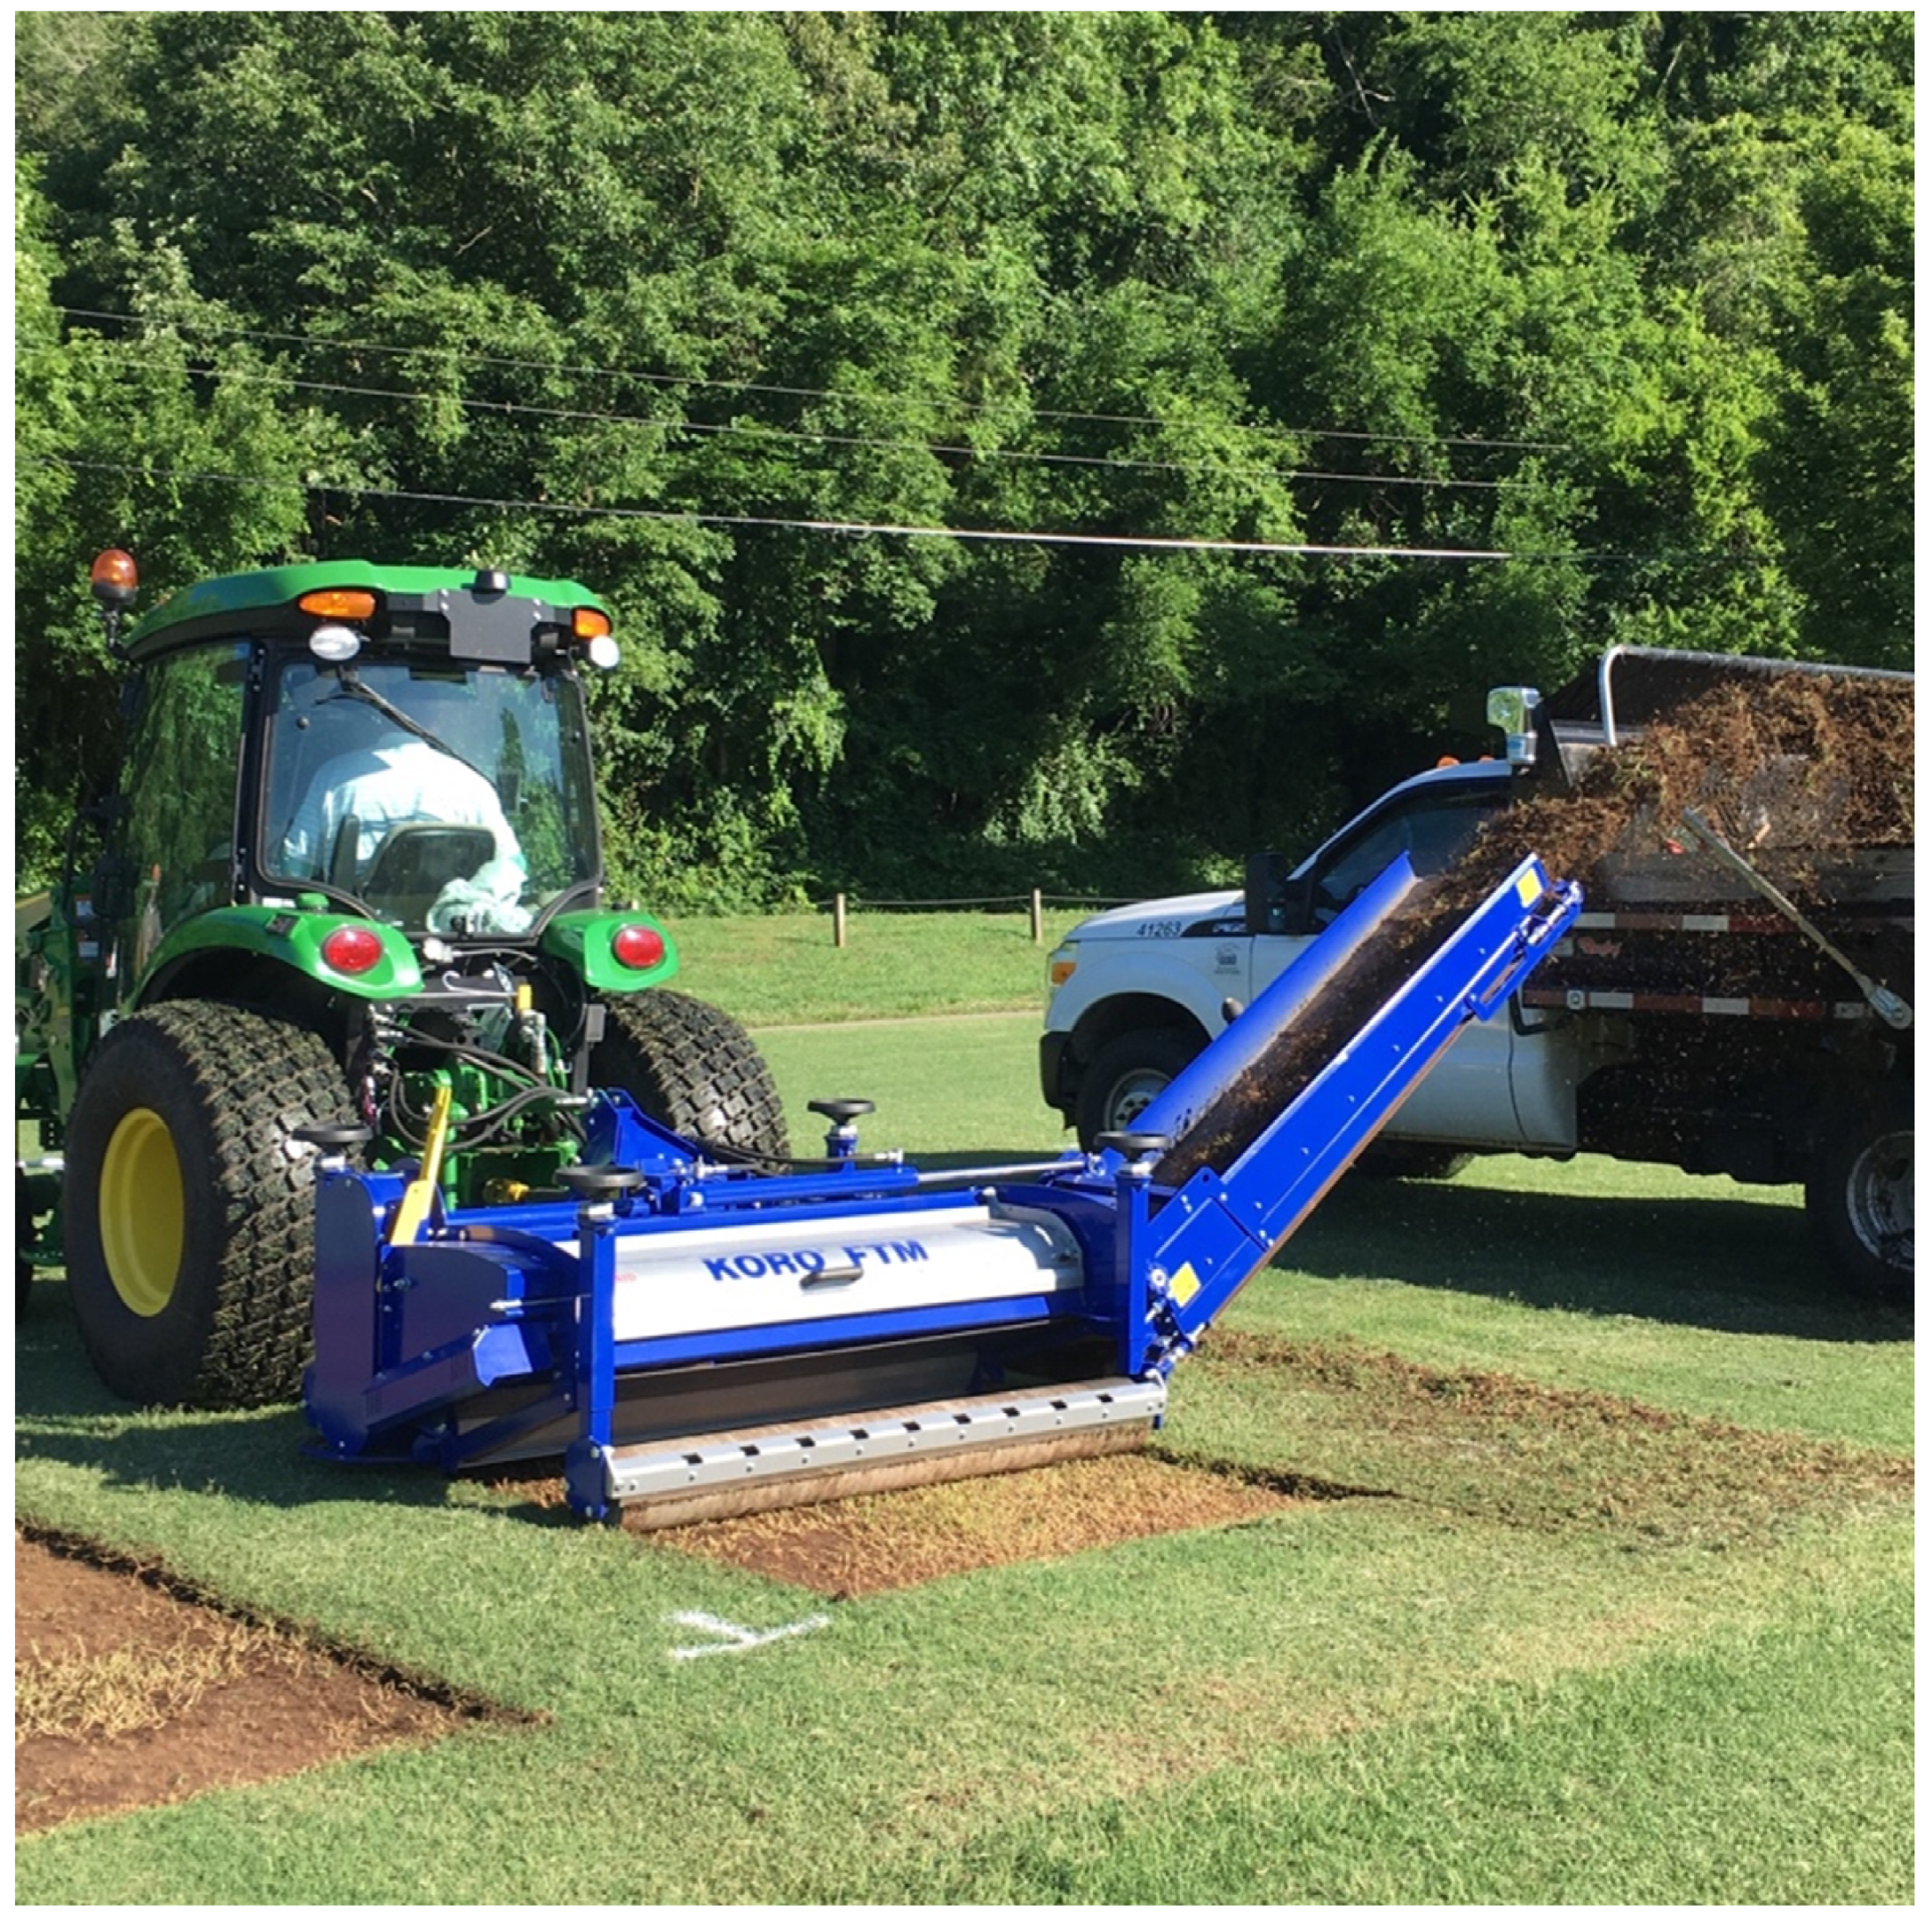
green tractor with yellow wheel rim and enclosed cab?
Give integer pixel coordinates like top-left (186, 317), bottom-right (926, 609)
top-left (16, 551), bottom-right (788, 1407)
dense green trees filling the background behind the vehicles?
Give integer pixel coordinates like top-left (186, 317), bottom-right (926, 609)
top-left (16, 11), bottom-right (1913, 904)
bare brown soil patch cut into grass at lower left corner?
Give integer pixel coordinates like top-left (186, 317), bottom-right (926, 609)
top-left (13, 1528), bottom-right (501, 1835)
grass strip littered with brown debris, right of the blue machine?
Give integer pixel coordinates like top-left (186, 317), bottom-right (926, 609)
top-left (1178, 1329), bottom-right (1913, 1549)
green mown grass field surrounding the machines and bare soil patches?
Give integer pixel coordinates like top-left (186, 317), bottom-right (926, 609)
top-left (16, 917), bottom-right (1913, 1905)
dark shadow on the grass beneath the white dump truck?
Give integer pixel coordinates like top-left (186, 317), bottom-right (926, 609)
top-left (1279, 1175), bottom-right (1913, 1344)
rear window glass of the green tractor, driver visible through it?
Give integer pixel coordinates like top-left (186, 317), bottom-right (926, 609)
top-left (261, 659), bottom-right (597, 937)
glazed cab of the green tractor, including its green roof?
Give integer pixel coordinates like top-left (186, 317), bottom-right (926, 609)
top-left (103, 562), bottom-right (616, 980)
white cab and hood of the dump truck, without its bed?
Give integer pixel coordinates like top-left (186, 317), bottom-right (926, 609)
top-left (1039, 761), bottom-right (1574, 1170)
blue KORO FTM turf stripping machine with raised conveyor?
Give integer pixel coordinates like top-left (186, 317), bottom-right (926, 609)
top-left (308, 858), bottom-right (1581, 1526)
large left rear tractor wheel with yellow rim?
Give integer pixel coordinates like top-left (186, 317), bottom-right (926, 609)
top-left (62, 1003), bottom-right (348, 1408)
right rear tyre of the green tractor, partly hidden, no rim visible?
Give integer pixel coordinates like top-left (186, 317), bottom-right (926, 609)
top-left (591, 989), bottom-right (792, 1163)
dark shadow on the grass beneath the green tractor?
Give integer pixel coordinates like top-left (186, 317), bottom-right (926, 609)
top-left (13, 1281), bottom-right (575, 1524)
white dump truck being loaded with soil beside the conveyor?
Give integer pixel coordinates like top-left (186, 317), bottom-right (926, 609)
top-left (1039, 649), bottom-right (1913, 1302)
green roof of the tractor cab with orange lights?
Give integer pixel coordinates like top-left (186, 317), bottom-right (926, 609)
top-left (126, 561), bottom-right (611, 667)
